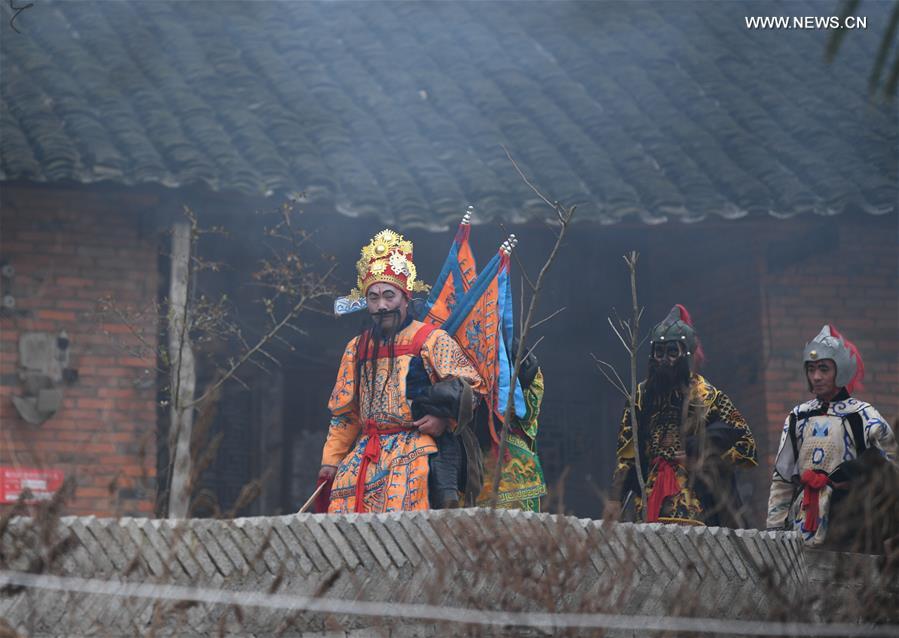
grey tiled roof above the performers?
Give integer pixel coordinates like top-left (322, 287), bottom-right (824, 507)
top-left (0, 0), bottom-right (899, 228)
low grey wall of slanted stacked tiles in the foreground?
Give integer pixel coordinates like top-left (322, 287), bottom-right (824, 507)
top-left (0, 509), bottom-right (832, 636)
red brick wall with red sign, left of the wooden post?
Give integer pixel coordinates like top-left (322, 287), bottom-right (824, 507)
top-left (0, 186), bottom-right (158, 515)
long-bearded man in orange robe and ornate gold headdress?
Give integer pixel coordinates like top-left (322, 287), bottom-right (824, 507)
top-left (319, 230), bottom-right (484, 512)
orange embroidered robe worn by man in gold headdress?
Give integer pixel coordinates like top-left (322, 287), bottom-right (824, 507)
top-left (322, 321), bottom-right (485, 513)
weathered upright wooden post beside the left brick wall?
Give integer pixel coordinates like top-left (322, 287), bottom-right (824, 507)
top-left (168, 222), bottom-right (196, 518)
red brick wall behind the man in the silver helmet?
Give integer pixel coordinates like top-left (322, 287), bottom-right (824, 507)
top-left (762, 215), bottom-right (899, 470)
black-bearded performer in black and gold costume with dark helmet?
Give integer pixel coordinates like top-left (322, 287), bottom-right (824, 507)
top-left (604, 304), bottom-right (757, 527)
